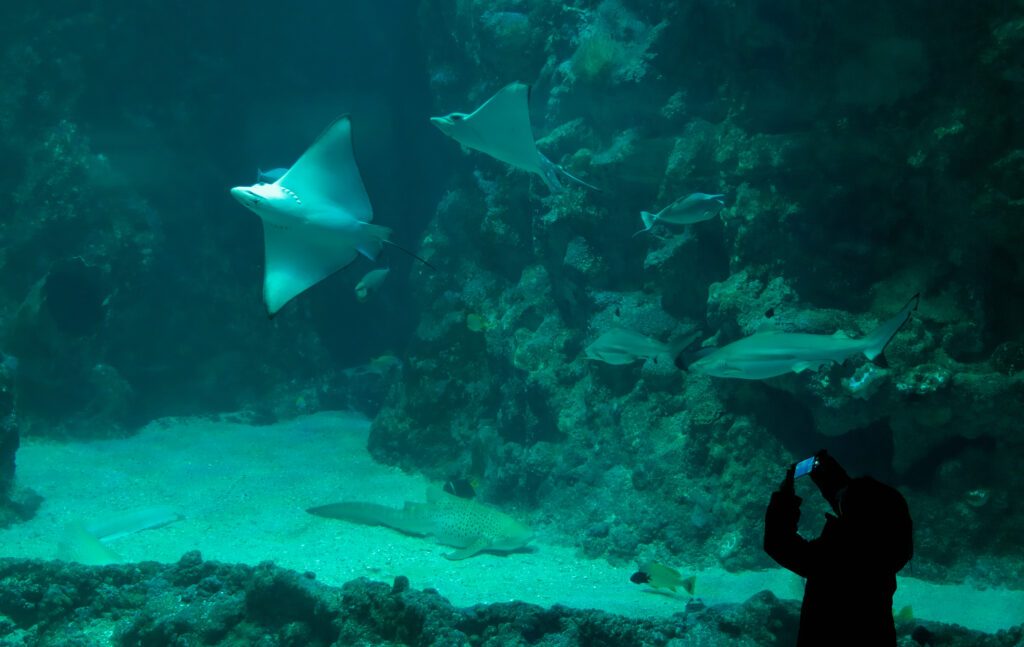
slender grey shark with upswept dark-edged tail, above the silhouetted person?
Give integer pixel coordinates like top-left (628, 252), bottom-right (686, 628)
top-left (687, 294), bottom-right (921, 380)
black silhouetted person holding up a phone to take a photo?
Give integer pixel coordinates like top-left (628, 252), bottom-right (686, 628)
top-left (764, 449), bottom-right (913, 647)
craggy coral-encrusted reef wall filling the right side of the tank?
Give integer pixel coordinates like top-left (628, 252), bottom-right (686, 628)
top-left (371, 0), bottom-right (1024, 586)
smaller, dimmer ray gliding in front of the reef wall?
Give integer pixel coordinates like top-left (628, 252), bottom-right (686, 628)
top-left (430, 83), bottom-right (600, 193)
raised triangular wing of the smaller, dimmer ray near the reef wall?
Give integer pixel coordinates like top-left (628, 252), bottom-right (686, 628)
top-left (452, 83), bottom-right (543, 174)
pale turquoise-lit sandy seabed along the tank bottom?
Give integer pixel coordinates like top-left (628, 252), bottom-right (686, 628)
top-left (0, 412), bottom-right (1024, 632)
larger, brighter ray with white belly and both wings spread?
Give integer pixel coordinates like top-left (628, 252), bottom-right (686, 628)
top-left (231, 115), bottom-right (391, 316)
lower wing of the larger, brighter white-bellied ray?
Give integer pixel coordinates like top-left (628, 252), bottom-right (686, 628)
top-left (263, 220), bottom-right (358, 316)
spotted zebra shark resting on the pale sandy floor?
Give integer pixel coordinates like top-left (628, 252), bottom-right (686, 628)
top-left (306, 486), bottom-right (534, 560)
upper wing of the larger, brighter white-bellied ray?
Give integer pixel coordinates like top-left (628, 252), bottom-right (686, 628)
top-left (278, 115), bottom-right (374, 222)
